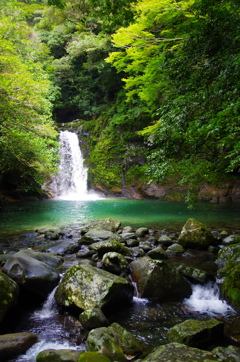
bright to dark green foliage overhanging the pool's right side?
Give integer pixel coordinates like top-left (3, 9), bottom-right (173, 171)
top-left (106, 0), bottom-right (240, 197)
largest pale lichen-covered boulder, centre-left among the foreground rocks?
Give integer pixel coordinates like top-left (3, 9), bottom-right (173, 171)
top-left (55, 265), bottom-right (134, 311)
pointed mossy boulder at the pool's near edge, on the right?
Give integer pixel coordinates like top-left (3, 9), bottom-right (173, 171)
top-left (178, 219), bottom-right (215, 249)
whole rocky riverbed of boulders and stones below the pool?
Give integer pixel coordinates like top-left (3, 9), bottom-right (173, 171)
top-left (0, 218), bottom-right (240, 362)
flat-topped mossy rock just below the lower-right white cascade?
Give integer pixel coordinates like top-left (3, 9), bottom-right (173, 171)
top-left (167, 318), bottom-right (224, 348)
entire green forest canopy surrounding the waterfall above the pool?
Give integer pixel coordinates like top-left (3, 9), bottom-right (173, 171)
top-left (0, 0), bottom-right (240, 199)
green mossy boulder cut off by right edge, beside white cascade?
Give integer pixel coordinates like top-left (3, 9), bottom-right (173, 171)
top-left (216, 244), bottom-right (240, 306)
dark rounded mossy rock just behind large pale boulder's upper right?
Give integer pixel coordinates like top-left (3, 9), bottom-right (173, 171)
top-left (102, 252), bottom-right (130, 275)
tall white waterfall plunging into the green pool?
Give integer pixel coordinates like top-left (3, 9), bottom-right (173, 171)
top-left (50, 131), bottom-right (99, 200)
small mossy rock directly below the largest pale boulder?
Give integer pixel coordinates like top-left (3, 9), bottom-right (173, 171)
top-left (79, 308), bottom-right (109, 330)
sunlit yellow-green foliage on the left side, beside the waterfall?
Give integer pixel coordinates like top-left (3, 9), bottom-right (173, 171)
top-left (0, 4), bottom-right (57, 194)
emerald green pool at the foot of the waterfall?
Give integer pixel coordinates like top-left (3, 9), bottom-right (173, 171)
top-left (0, 199), bottom-right (240, 233)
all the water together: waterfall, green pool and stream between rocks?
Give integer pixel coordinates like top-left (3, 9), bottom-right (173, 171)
top-left (0, 131), bottom-right (240, 362)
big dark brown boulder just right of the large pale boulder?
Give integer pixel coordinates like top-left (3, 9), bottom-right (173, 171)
top-left (131, 257), bottom-right (192, 302)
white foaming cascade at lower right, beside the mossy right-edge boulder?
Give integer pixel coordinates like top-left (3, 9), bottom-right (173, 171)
top-left (184, 283), bottom-right (235, 316)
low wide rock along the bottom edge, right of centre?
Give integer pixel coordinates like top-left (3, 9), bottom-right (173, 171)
top-left (142, 343), bottom-right (219, 362)
